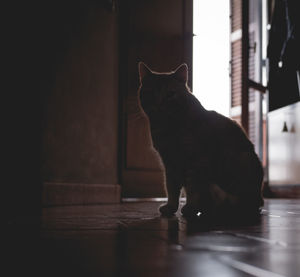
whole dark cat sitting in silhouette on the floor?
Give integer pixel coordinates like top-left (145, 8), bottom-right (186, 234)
top-left (139, 63), bottom-right (263, 216)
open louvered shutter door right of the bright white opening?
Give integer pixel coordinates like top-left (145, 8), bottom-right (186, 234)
top-left (230, 0), bottom-right (262, 158)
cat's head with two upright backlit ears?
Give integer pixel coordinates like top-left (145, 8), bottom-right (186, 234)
top-left (138, 62), bottom-right (190, 119)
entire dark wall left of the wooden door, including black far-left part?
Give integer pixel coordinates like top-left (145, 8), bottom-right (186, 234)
top-left (2, 0), bottom-right (118, 220)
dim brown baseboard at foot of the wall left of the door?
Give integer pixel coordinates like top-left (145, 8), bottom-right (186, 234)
top-left (43, 183), bottom-right (121, 206)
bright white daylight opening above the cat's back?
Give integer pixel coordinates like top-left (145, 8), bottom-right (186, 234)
top-left (193, 0), bottom-right (230, 116)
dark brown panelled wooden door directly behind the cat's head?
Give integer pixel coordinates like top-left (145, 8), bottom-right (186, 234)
top-left (119, 0), bottom-right (192, 197)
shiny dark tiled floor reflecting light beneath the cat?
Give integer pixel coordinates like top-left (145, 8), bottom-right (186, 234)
top-left (2, 199), bottom-right (300, 277)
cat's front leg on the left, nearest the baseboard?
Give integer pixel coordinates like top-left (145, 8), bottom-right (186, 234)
top-left (159, 170), bottom-right (181, 216)
